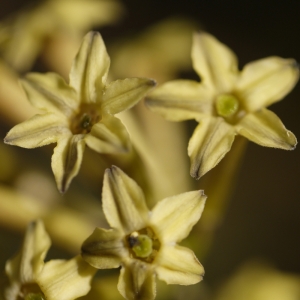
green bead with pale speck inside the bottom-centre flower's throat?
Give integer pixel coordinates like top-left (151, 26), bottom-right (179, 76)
top-left (129, 232), bottom-right (153, 258)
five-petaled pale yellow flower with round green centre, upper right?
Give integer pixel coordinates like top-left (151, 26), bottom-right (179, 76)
top-left (147, 33), bottom-right (299, 179)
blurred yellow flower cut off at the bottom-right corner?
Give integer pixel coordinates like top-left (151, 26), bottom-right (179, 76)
top-left (214, 263), bottom-right (300, 300)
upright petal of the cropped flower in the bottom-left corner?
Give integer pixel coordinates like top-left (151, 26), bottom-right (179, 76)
top-left (5, 220), bottom-right (51, 283)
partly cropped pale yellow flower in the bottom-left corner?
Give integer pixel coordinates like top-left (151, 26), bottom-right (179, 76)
top-left (4, 220), bottom-right (95, 300)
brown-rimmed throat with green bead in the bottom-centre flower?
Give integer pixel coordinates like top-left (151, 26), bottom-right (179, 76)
top-left (127, 228), bottom-right (160, 263)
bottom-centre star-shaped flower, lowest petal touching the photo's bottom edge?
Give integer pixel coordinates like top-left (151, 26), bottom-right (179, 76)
top-left (82, 166), bottom-right (206, 300)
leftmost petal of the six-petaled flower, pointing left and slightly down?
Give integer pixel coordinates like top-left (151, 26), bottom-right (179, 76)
top-left (4, 113), bottom-right (69, 148)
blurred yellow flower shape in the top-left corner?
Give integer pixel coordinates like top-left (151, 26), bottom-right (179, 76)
top-left (0, 0), bottom-right (121, 71)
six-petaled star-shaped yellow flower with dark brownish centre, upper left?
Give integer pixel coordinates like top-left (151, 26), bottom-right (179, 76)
top-left (4, 32), bottom-right (155, 192)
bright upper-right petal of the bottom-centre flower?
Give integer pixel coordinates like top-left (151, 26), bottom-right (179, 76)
top-left (150, 190), bottom-right (206, 243)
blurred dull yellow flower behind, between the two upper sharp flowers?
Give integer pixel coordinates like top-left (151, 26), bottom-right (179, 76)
top-left (111, 18), bottom-right (196, 82)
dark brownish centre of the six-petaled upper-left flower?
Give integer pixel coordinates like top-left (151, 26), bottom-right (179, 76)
top-left (70, 105), bottom-right (101, 134)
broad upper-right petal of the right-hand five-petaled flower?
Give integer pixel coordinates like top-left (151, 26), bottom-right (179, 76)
top-left (236, 57), bottom-right (299, 112)
